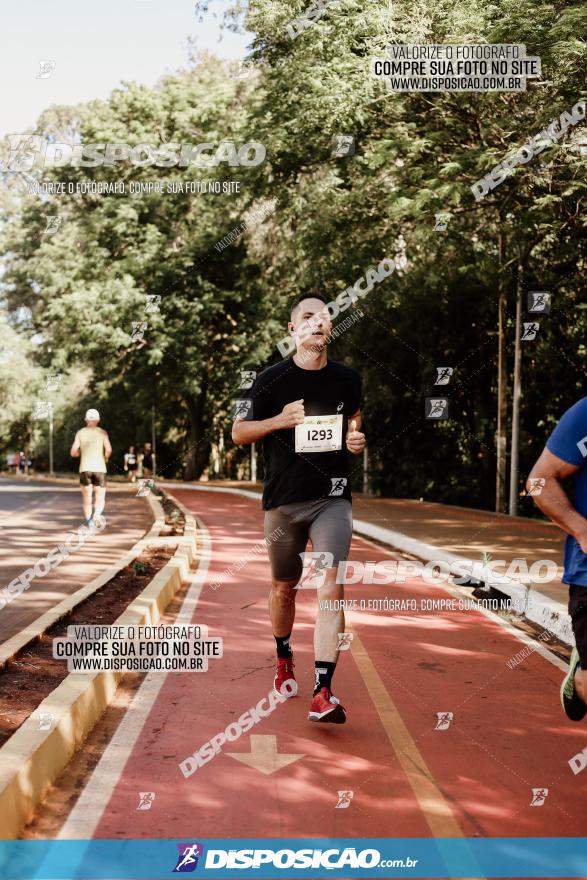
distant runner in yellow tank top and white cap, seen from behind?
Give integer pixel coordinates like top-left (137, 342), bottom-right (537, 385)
top-left (71, 409), bottom-right (112, 525)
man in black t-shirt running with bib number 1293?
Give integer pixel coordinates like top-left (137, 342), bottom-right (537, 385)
top-left (232, 296), bottom-right (365, 724)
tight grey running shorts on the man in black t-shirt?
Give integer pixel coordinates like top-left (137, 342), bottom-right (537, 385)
top-left (265, 498), bottom-right (353, 582)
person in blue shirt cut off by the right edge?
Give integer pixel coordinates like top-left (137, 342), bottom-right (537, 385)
top-left (526, 397), bottom-right (587, 721)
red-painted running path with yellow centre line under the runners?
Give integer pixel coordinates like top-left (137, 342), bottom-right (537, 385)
top-left (62, 490), bottom-right (587, 839)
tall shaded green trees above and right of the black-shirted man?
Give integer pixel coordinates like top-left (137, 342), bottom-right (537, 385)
top-left (242, 0), bottom-right (587, 506)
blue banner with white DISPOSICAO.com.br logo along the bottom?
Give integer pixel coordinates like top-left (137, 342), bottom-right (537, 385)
top-left (0, 837), bottom-right (587, 880)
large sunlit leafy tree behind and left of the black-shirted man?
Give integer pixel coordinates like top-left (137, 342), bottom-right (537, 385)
top-left (4, 57), bottom-right (282, 478)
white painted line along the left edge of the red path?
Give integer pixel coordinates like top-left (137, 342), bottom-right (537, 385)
top-left (56, 517), bottom-right (212, 840)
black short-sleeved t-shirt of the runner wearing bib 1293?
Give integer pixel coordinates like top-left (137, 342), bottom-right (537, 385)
top-left (247, 359), bottom-right (361, 510)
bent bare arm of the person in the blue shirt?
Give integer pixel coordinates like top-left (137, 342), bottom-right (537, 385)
top-left (526, 449), bottom-right (587, 553)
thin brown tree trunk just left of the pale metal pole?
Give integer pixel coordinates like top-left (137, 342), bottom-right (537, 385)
top-left (495, 227), bottom-right (508, 513)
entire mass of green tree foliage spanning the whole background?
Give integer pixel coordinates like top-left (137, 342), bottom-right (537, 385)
top-left (0, 0), bottom-right (587, 512)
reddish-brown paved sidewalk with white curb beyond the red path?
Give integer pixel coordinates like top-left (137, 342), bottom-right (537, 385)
top-left (176, 480), bottom-right (574, 645)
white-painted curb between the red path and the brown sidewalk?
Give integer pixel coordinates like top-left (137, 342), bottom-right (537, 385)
top-left (165, 483), bottom-right (575, 646)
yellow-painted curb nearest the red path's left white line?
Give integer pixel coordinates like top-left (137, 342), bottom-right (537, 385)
top-left (0, 496), bottom-right (197, 840)
